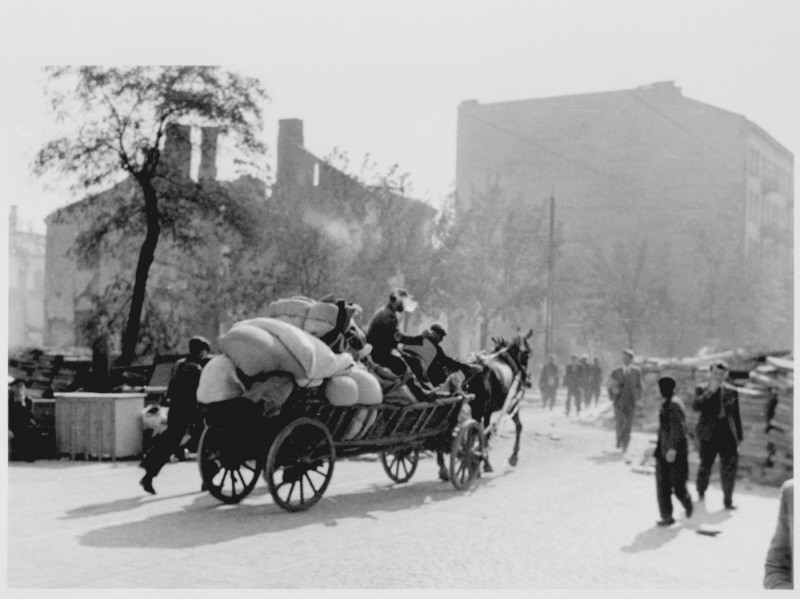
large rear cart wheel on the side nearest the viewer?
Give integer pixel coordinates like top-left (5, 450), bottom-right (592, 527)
top-left (264, 418), bottom-right (336, 512)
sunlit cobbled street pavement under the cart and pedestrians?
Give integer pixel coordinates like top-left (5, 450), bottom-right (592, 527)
top-left (7, 394), bottom-right (778, 595)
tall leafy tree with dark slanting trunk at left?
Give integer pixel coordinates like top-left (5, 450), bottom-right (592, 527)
top-left (34, 66), bottom-right (266, 364)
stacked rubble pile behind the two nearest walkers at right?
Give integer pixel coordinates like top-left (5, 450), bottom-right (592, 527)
top-left (636, 351), bottom-right (794, 484)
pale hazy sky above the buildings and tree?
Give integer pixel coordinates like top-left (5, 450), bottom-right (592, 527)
top-left (0, 0), bottom-right (800, 231)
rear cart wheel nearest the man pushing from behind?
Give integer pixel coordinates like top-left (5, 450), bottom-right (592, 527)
top-left (197, 427), bottom-right (262, 503)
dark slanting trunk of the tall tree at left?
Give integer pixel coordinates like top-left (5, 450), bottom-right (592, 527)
top-left (118, 177), bottom-right (161, 366)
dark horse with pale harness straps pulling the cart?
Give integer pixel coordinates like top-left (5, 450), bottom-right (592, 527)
top-left (436, 330), bottom-right (533, 480)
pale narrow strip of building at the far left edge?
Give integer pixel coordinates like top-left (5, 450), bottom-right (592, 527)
top-left (8, 206), bottom-right (45, 349)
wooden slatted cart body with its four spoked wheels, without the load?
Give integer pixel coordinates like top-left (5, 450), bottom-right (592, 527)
top-left (198, 388), bottom-right (484, 512)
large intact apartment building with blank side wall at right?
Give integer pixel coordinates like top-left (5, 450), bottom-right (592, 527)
top-left (456, 82), bottom-right (794, 351)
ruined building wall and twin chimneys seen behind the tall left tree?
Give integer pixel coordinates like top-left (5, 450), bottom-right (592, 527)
top-left (44, 124), bottom-right (237, 353)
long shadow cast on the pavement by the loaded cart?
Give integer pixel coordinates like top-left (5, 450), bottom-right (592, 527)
top-left (79, 477), bottom-right (482, 549)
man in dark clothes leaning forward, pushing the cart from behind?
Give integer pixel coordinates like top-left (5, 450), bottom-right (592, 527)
top-left (139, 336), bottom-right (211, 495)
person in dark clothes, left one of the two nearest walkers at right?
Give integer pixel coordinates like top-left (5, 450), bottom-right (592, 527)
top-left (655, 376), bottom-right (693, 526)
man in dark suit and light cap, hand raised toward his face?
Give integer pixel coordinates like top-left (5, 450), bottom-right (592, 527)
top-left (692, 360), bottom-right (744, 510)
